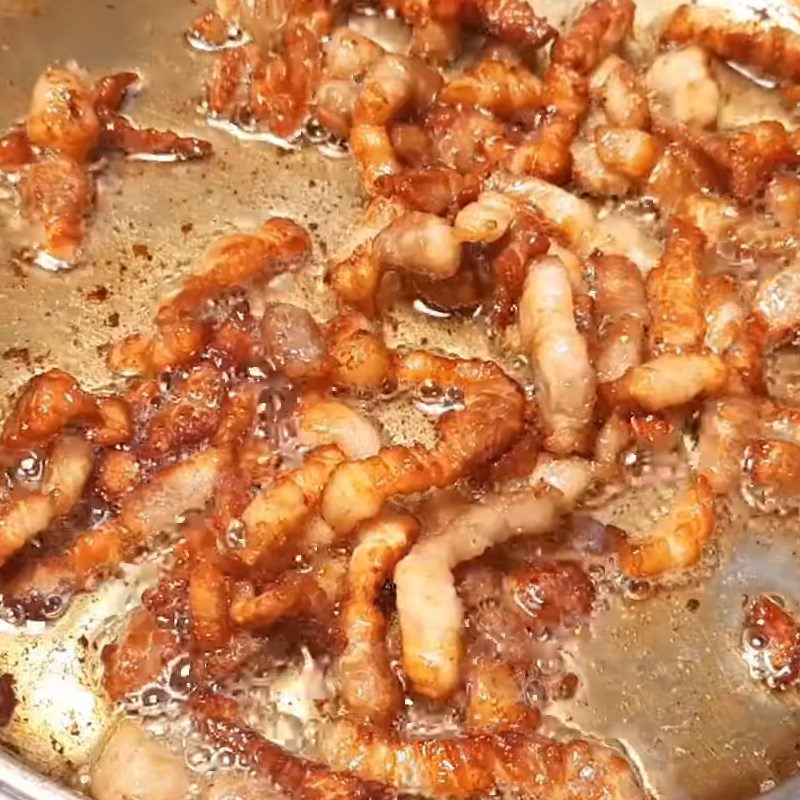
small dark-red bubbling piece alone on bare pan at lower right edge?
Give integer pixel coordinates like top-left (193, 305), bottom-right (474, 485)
top-left (743, 595), bottom-right (800, 689)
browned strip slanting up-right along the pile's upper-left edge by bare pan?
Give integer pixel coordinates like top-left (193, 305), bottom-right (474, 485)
top-left (157, 217), bottom-right (311, 324)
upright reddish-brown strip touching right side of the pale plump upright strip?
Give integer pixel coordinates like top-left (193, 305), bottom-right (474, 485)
top-left (592, 255), bottom-right (650, 383)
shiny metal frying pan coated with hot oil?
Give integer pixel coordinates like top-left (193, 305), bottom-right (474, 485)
top-left (0, 0), bottom-right (800, 800)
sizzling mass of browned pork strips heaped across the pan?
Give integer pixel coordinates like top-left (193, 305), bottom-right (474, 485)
top-left (7, 0), bottom-right (800, 800)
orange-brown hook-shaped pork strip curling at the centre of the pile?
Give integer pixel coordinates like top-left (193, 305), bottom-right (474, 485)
top-left (322, 351), bottom-right (525, 534)
